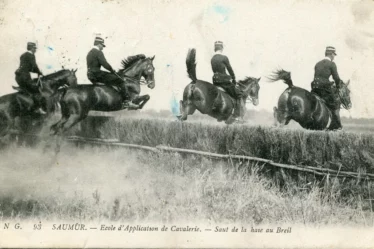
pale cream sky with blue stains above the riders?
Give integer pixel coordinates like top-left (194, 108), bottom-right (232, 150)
top-left (0, 0), bottom-right (374, 118)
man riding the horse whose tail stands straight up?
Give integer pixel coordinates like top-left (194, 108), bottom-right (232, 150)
top-left (210, 41), bottom-right (242, 121)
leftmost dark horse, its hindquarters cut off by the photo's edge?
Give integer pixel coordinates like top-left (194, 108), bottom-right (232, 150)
top-left (0, 69), bottom-right (77, 137)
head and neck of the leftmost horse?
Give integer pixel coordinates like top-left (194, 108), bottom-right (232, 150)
top-left (39, 69), bottom-right (78, 96)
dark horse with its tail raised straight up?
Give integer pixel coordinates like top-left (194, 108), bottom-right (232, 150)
top-left (179, 49), bottom-right (261, 124)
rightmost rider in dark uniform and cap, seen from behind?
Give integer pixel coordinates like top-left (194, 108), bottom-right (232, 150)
top-left (312, 46), bottom-right (342, 129)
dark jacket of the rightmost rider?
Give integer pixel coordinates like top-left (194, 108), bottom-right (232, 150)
top-left (314, 57), bottom-right (340, 86)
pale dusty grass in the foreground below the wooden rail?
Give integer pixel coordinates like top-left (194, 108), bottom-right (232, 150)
top-left (0, 144), bottom-right (374, 226)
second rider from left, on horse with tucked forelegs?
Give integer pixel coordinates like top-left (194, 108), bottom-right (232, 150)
top-left (86, 37), bottom-right (139, 108)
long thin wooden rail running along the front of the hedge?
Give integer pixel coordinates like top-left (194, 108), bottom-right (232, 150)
top-left (67, 136), bottom-right (374, 181)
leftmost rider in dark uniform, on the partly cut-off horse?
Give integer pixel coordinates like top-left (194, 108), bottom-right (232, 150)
top-left (15, 42), bottom-right (46, 114)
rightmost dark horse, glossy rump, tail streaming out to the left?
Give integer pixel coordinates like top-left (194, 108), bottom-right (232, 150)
top-left (269, 69), bottom-right (352, 130)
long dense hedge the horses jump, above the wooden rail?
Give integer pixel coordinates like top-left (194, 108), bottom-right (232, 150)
top-left (77, 117), bottom-right (374, 173)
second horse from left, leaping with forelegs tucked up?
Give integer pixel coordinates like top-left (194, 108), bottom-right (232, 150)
top-left (50, 54), bottom-right (155, 135)
